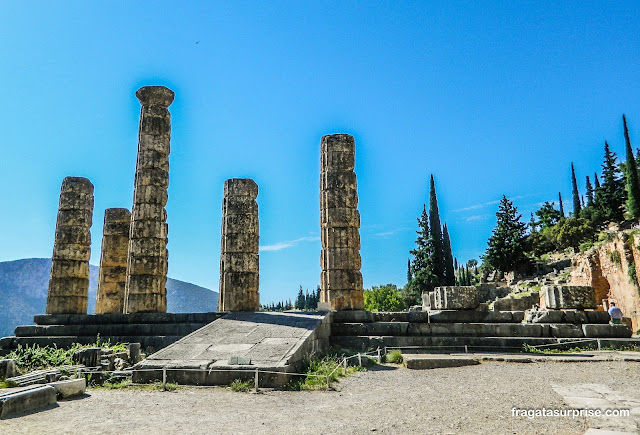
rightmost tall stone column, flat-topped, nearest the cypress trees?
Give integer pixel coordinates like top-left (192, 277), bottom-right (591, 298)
top-left (320, 134), bottom-right (364, 310)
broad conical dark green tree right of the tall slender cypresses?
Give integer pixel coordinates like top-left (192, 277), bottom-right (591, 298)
top-left (483, 195), bottom-right (527, 272)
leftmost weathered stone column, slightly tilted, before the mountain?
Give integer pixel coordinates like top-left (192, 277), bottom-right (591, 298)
top-left (46, 177), bottom-right (93, 314)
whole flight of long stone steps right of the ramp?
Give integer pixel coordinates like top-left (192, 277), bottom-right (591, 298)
top-left (331, 310), bottom-right (640, 353)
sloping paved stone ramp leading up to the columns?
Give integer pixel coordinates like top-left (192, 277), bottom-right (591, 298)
top-left (133, 312), bottom-right (331, 387)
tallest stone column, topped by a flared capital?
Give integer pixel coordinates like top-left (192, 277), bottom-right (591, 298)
top-left (125, 86), bottom-right (174, 313)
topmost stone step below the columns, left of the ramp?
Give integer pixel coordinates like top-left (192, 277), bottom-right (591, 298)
top-left (33, 312), bottom-right (226, 325)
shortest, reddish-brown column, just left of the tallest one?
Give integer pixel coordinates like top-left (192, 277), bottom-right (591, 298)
top-left (95, 208), bottom-right (131, 314)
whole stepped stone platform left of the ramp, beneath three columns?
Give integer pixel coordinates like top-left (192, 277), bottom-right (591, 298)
top-left (0, 313), bottom-right (225, 353)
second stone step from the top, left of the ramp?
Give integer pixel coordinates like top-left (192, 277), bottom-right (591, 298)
top-left (15, 323), bottom-right (204, 341)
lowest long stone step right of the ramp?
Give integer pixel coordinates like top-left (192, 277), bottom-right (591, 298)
top-left (331, 336), bottom-right (640, 353)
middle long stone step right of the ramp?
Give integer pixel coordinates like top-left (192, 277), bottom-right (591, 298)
top-left (331, 322), bottom-right (631, 338)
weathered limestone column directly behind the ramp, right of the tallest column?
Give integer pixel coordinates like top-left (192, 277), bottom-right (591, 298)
top-left (218, 178), bottom-right (260, 311)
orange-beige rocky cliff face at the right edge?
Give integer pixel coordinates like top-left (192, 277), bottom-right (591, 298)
top-left (571, 230), bottom-right (640, 334)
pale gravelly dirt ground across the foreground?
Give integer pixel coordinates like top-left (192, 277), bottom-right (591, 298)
top-left (0, 362), bottom-right (640, 435)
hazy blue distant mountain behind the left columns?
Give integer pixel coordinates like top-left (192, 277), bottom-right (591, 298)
top-left (0, 258), bottom-right (218, 337)
